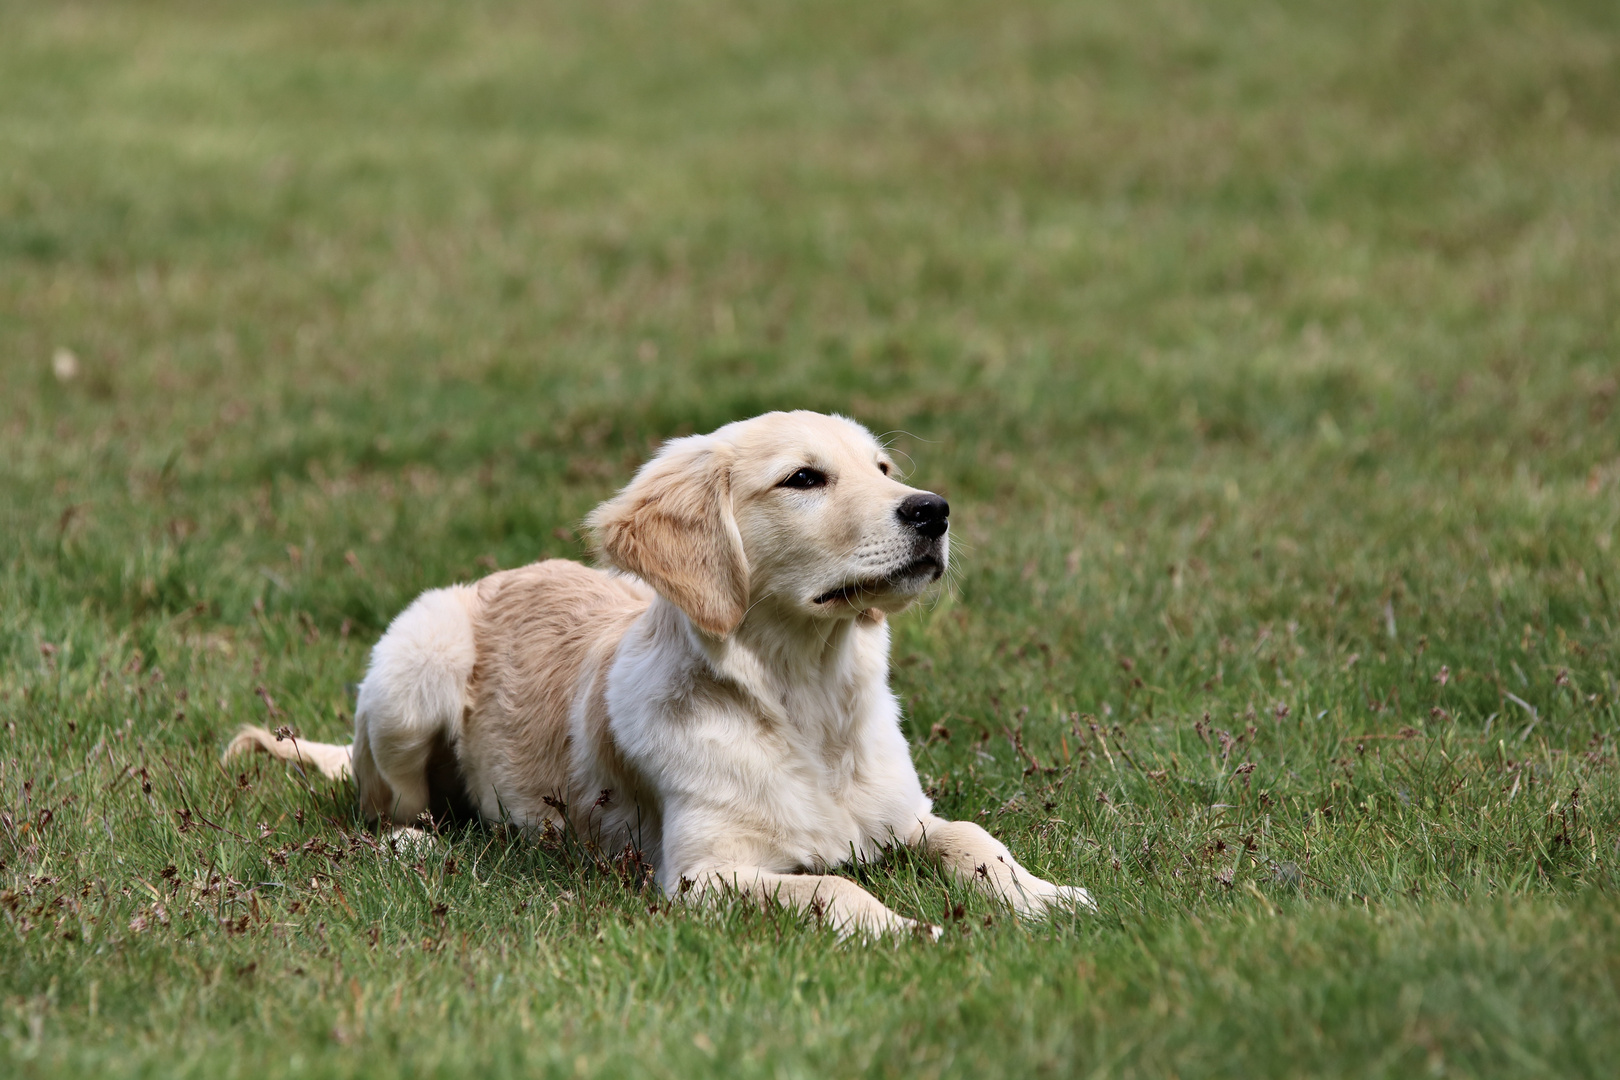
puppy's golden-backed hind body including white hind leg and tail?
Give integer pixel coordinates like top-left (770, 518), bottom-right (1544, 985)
top-left (225, 559), bottom-right (653, 826)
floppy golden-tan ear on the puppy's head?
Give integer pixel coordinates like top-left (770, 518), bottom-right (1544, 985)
top-left (586, 436), bottom-right (748, 638)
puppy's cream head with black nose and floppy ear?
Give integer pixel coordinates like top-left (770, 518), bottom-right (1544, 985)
top-left (588, 413), bottom-right (951, 638)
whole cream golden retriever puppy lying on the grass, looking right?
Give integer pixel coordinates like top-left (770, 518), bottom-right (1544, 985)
top-left (225, 413), bottom-right (1092, 934)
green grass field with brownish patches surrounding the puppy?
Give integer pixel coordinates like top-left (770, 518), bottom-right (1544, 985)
top-left (0, 0), bottom-right (1620, 1078)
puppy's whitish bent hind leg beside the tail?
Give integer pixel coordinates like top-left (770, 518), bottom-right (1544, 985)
top-left (353, 586), bottom-right (478, 824)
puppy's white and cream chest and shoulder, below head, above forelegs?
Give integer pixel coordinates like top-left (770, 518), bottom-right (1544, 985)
top-left (608, 615), bottom-right (930, 881)
